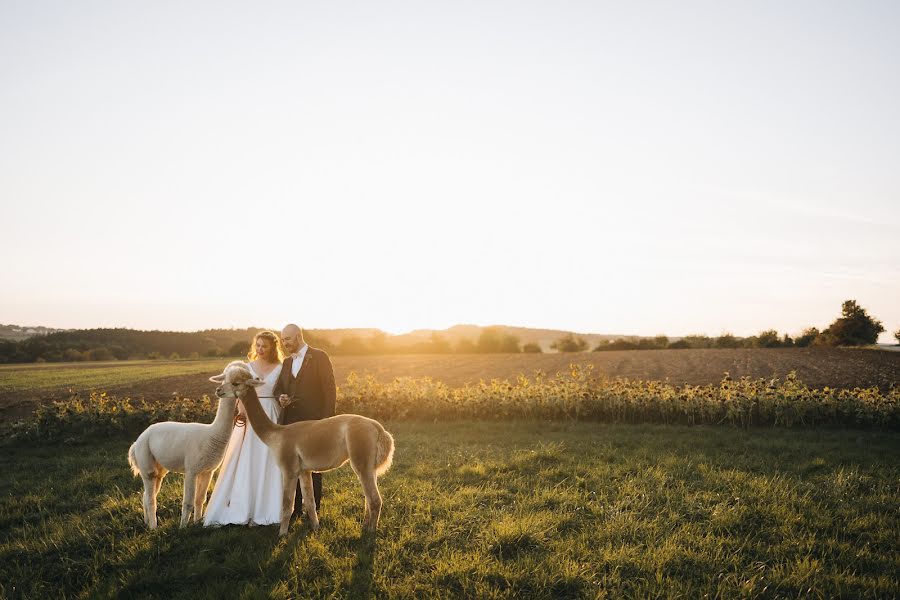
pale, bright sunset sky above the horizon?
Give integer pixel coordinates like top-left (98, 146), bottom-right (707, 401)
top-left (0, 0), bottom-right (900, 342)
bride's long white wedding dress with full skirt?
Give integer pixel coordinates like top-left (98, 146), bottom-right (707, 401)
top-left (203, 364), bottom-right (281, 526)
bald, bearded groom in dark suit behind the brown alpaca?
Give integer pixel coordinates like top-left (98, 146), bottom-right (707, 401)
top-left (273, 323), bottom-right (337, 514)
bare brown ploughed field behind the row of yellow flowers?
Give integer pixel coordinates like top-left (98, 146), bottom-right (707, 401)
top-left (0, 348), bottom-right (900, 419)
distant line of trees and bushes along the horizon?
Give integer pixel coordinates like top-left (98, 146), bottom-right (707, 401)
top-left (0, 300), bottom-right (900, 363)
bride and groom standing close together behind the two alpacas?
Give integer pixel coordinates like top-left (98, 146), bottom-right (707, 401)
top-left (203, 324), bottom-right (337, 525)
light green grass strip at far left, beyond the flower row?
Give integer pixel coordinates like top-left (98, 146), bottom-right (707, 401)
top-left (0, 358), bottom-right (224, 393)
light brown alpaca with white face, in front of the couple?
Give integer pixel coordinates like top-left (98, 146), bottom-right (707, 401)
top-left (209, 361), bottom-right (394, 535)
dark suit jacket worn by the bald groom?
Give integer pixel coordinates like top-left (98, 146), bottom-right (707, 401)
top-left (273, 346), bottom-right (337, 424)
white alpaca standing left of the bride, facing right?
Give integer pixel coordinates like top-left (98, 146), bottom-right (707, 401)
top-left (128, 397), bottom-right (235, 529)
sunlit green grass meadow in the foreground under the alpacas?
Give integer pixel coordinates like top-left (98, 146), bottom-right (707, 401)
top-left (0, 421), bottom-right (900, 598)
